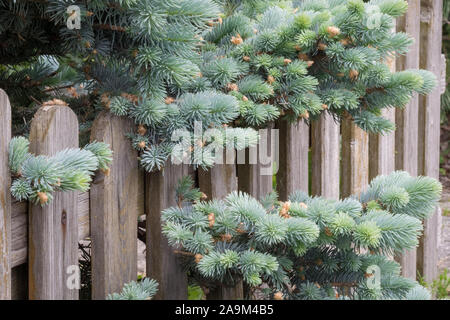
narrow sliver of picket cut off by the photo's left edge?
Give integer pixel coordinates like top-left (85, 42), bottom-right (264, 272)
top-left (0, 89), bottom-right (12, 300)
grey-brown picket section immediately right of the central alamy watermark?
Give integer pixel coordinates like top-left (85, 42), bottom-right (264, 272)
top-left (277, 120), bottom-right (309, 201)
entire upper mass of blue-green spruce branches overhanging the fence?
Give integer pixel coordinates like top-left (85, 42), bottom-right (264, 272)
top-left (0, 0), bottom-right (436, 175)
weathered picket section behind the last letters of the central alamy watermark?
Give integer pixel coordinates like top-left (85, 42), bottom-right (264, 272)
top-left (237, 124), bottom-right (279, 199)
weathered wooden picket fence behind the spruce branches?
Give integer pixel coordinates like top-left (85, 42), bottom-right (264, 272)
top-left (0, 0), bottom-right (445, 299)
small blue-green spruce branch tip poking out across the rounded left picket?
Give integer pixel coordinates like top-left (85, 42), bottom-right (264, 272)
top-left (9, 137), bottom-right (112, 206)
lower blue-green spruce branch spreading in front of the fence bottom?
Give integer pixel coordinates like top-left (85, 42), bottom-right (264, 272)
top-left (162, 171), bottom-right (441, 299)
